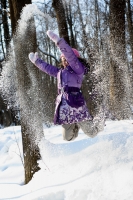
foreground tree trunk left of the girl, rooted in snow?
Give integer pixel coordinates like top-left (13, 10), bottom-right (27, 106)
top-left (9, 0), bottom-right (43, 183)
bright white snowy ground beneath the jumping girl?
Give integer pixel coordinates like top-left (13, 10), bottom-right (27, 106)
top-left (0, 121), bottom-right (133, 200)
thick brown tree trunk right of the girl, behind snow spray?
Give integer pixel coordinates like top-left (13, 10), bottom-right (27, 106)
top-left (110, 0), bottom-right (131, 119)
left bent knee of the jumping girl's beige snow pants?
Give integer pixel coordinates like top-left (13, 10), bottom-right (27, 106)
top-left (62, 124), bottom-right (79, 141)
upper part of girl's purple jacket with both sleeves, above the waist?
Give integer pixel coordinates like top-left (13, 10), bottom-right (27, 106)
top-left (35, 38), bottom-right (84, 88)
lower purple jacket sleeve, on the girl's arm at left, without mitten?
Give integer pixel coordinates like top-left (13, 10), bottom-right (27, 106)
top-left (35, 58), bottom-right (59, 77)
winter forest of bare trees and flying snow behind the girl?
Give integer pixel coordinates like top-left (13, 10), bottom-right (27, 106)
top-left (0, 0), bottom-right (133, 200)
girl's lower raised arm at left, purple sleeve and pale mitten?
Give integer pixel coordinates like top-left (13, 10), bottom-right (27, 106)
top-left (29, 52), bottom-right (59, 77)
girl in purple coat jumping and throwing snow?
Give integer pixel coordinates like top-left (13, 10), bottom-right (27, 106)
top-left (29, 31), bottom-right (104, 141)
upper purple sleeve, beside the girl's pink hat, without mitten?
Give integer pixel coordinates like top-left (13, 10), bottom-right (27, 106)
top-left (57, 38), bottom-right (85, 75)
